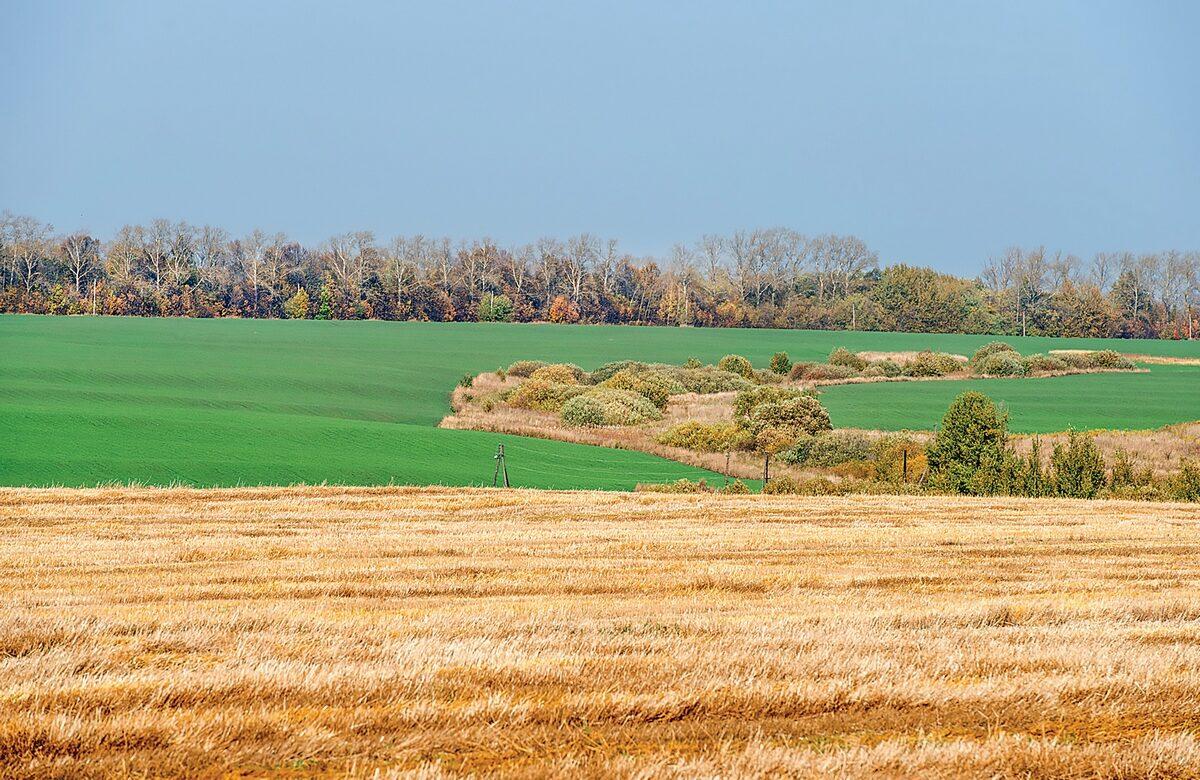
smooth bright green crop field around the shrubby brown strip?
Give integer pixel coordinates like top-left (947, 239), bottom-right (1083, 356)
top-left (0, 316), bottom-right (1200, 488)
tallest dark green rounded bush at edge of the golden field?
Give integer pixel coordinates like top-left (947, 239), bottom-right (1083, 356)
top-left (925, 391), bottom-right (1008, 493)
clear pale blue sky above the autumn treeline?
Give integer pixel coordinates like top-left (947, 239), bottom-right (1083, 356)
top-left (0, 0), bottom-right (1200, 274)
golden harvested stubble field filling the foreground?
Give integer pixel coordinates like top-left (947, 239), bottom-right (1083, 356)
top-left (0, 487), bottom-right (1200, 778)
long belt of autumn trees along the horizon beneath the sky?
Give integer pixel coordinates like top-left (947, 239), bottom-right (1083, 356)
top-left (0, 212), bottom-right (1200, 338)
